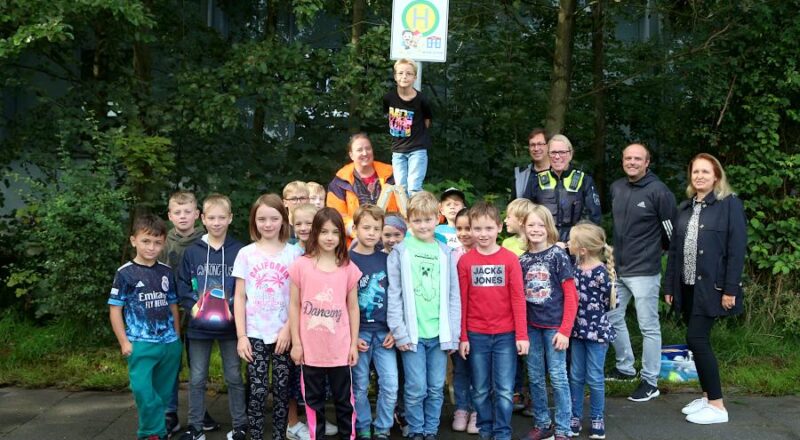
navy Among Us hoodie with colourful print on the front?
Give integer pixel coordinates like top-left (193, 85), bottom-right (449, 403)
top-left (178, 235), bottom-right (243, 339)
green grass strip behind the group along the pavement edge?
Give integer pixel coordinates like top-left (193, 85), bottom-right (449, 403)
top-left (0, 313), bottom-right (800, 397)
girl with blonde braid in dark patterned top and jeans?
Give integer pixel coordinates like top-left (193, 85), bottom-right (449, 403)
top-left (567, 223), bottom-right (616, 439)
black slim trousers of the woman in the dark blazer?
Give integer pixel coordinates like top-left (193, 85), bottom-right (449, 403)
top-left (681, 285), bottom-right (722, 400)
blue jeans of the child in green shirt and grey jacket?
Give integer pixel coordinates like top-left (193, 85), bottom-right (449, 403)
top-left (403, 338), bottom-right (447, 435)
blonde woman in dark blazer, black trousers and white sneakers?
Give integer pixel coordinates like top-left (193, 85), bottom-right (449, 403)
top-left (664, 153), bottom-right (747, 424)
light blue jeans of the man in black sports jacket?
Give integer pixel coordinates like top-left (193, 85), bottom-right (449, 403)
top-left (608, 275), bottom-right (661, 386)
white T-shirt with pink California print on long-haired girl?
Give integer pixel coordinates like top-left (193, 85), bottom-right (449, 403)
top-left (232, 243), bottom-right (303, 344)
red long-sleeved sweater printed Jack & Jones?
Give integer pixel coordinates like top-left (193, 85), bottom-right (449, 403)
top-left (458, 248), bottom-right (528, 342)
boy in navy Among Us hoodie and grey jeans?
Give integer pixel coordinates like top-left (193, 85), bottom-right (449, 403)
top-left (178, 194), bottom-right (247, 440)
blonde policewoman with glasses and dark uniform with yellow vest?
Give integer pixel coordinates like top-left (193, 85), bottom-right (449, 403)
top-left (524, 134), bottom-right (602, 247)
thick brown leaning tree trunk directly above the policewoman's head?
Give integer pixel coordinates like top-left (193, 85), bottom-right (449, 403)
top-left (545, 0), bottom-right (576, 136)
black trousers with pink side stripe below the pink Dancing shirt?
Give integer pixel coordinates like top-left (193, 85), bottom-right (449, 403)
top-left (300, 365), bottom-right (356, 440)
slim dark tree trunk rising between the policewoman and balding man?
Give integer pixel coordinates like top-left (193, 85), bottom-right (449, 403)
top-left (592, 0), bottom-right (606, 206)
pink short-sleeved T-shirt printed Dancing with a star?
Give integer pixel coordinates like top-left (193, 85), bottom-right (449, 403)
top-left (289, 257), bottom-right (361, 367)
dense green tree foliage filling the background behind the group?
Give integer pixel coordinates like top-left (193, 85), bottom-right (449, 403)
top-left (0, 0), bottom-right (800, 328)
